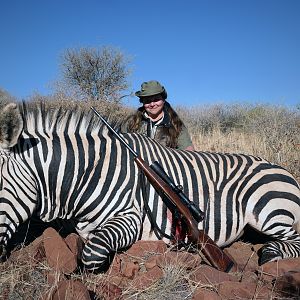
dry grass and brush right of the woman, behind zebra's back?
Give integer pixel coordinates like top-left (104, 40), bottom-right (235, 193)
top-left (178, 104), bottom-right (300, 179)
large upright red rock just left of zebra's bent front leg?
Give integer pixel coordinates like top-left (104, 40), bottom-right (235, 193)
top-left (43, 228), bottom-right (77, 274)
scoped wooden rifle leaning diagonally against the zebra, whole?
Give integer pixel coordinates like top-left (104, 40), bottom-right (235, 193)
top-left (91, 106), bottom-right (236, 272)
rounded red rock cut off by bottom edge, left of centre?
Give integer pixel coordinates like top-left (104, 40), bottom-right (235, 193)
top-left (50, 280), bottom-right (91, 300)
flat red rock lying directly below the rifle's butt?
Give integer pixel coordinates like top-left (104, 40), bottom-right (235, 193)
top-left (189, 265), bottom-right (238, 285)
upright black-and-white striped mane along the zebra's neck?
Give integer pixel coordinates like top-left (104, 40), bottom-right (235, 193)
top-left (19, 102), bottom-right (116, 134)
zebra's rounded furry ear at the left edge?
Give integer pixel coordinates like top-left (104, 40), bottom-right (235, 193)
top-left (0, 103), bottom-right (23, 149)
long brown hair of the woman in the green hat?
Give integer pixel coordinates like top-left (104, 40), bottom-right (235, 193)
top-left (128, 101), bottom-right (183, 148)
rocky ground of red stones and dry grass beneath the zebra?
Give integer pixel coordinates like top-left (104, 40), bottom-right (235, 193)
top-left (0, 227), bottom-right (300, 300)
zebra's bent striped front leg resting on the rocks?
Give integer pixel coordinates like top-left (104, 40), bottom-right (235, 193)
top-left (82, 214), bottom-right (141, 271)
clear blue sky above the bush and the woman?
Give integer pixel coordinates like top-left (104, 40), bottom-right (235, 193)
top-left (0, 0), bottom-right (300, 106)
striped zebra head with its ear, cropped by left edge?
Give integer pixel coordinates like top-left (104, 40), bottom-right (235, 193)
top-left (0, 103), bottom-right (36, 259)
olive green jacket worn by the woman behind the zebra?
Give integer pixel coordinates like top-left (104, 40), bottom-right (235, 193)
top-left (120, 113), bottom-right (193, 150)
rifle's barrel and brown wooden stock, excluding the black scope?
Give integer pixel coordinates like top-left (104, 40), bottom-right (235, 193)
top-left (91, 107), bottom-right (236, 272)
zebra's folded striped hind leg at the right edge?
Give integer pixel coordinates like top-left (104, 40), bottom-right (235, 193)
top-left (259, 226), bottom-right (300, 265)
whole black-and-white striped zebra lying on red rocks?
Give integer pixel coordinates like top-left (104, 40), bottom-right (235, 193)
top-left (0, 103), bottom-right (300, 270)
